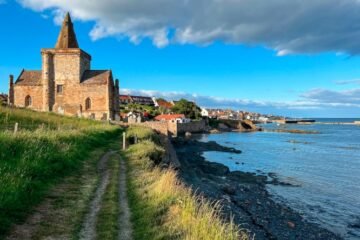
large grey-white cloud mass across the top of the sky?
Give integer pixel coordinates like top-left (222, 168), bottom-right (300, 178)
top-left (16, 0), bottom-right (360, 56)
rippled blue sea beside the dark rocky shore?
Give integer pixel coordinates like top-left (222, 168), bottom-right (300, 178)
top-left (200, 118), bottom-right (360, 240)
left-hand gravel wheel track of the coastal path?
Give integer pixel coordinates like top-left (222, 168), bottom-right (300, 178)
top-left (80, 151), bottom-right (115, 240)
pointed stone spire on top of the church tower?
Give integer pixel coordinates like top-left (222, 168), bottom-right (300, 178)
top-left (55, 13), bottom-right (79, 49)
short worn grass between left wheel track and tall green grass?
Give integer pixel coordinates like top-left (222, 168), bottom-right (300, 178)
top-left (5, 148), bottom-right (107, 240)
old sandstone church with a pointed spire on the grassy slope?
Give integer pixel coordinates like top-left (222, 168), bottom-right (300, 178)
top-left (8, 13), bottom-right (119, 120)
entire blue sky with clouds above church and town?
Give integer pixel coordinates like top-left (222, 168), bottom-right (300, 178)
top-left (0, 0), bottom-right (360, 117)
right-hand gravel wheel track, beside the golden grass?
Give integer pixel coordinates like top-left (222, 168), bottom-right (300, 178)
top-left (118, 156), bottom-right (133, 240)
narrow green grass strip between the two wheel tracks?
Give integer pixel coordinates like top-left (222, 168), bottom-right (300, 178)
top-left (96, 154), bottom-right (120, 240)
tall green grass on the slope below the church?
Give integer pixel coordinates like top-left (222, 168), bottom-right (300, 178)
top-left (0, 107), bottom-right (119, 238)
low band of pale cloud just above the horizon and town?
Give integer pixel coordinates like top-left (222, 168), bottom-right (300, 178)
top-left (120, 89), bottom-right (360, 114)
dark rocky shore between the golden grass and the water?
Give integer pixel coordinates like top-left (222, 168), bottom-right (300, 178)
top-left (173, 138), bottom-right (341, 240)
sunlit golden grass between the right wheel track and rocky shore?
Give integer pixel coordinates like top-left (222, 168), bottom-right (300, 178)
top-left (126, 126), bottom-right (248, 240)
